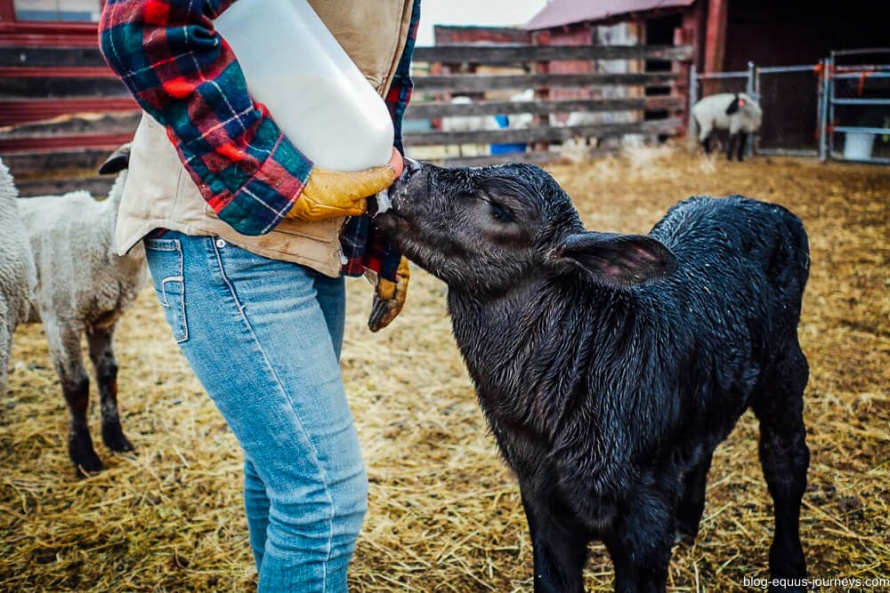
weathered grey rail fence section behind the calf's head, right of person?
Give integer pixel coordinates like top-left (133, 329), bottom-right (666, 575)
top-left (404, 45), bottom-right (692, 165)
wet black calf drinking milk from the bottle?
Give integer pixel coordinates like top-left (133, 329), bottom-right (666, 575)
top-left (375, 164), bottom-right (809, 593)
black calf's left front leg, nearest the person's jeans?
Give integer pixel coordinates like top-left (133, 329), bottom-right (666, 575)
top-left (522, 492), bottom-right (589, 593)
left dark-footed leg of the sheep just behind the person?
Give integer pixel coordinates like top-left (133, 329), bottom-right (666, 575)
top-left (41, 320), bottom-right (103, 473)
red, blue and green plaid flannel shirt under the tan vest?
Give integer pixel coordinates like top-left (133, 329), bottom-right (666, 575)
top-left (99, 0), bottom-right (420, 280)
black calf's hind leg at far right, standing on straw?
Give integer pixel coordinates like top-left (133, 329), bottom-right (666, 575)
top-left (753, 344), bottom-right (810, 592)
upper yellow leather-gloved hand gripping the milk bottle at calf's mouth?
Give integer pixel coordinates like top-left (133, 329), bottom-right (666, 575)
top-left (287, 148), bottom-right (404, 221)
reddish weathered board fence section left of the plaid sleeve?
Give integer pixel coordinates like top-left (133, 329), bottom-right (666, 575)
top-left (0, 28), bottom-right (139, 196)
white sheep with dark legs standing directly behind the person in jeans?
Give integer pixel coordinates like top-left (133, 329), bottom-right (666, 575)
top-left (19, 145), bottom-right (148, 473)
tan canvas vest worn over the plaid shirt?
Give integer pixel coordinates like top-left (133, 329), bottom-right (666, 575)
top-left (115, 0), bottom-right (412, 277)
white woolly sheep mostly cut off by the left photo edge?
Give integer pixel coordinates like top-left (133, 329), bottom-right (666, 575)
top-left (0, 159), bottom-right (37, 396)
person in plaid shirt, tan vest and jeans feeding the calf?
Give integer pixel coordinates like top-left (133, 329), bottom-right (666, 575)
top-left (99, 0), bottom-right (420, 593)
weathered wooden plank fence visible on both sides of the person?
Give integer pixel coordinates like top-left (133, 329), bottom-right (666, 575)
top-left (0, 40), bottom-right (692, 195)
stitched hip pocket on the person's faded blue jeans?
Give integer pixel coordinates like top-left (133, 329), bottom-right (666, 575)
top-left (143, 239), bottom-right (189, 343)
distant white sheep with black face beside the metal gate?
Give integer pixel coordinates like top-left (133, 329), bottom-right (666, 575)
top-left (692, 93), bottom-right (763, 161)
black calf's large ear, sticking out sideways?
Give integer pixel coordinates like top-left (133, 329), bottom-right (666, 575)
top-left (553, 233), bottom-right (677, 287)
